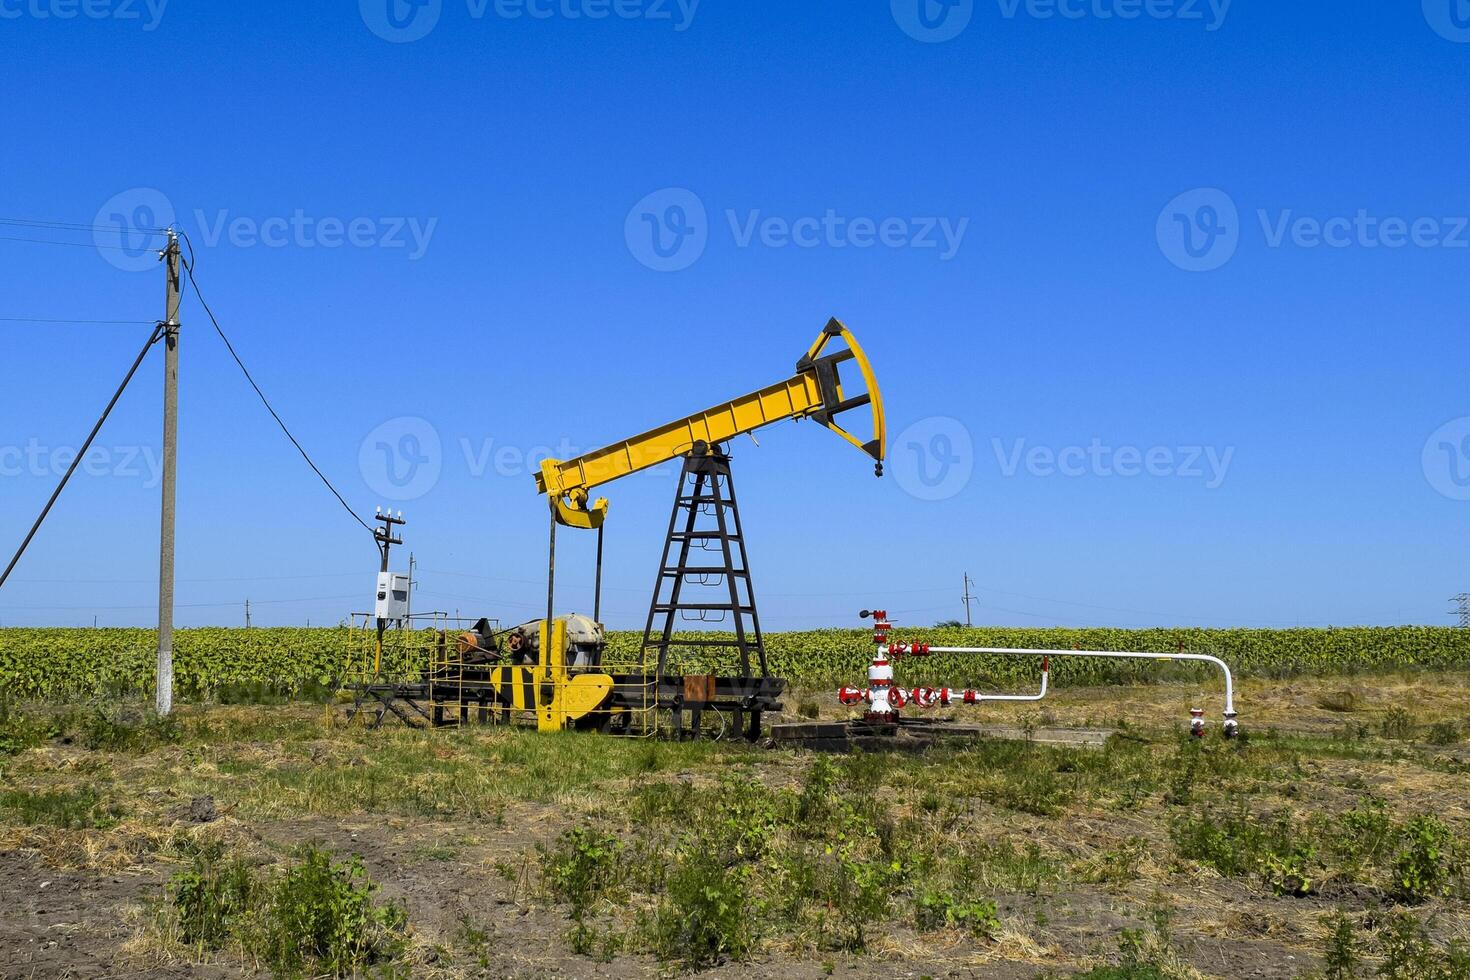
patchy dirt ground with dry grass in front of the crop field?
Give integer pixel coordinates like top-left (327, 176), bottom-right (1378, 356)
top-left (0, 676), bottom-right (1470, 979)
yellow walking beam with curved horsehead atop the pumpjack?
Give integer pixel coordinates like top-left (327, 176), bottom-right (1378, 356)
top-left (537, 319), bottom-right (888, 529)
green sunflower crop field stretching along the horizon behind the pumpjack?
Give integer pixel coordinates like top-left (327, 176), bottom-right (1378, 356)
top-left (0, 626), bottom-right (1470, 701)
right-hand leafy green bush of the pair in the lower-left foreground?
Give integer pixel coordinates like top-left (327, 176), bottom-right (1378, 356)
top-left (260, 846), bottom-right (407, 977)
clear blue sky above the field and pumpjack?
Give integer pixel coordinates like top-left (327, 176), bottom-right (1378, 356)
top-left (0, 0), bottom-right (1470, 629)
